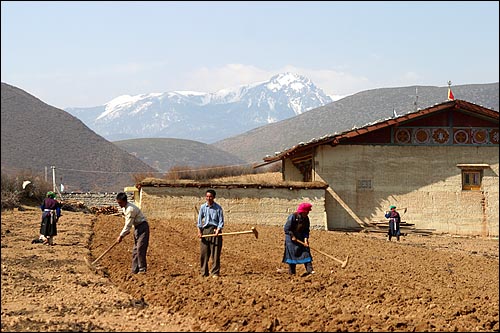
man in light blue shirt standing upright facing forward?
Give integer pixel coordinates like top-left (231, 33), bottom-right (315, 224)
top-left (197, 190), bottom-right (224, 278)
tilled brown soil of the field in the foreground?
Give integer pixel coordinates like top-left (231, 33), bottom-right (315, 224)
top-left (1, 209), bottom-right (499, 332)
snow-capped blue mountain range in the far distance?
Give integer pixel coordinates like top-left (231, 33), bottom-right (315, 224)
top-left (65, 73), bottom-right (333, 143)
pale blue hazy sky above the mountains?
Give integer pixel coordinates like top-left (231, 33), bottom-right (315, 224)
top-left (1, 1), bottom-right (499, 108)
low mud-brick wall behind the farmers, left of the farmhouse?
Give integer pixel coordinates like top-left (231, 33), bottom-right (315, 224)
top-left (141, 186), bottom-right (326, 230)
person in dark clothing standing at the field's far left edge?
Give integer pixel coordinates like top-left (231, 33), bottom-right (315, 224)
top-left (40, 191), bottom-right (62, 245)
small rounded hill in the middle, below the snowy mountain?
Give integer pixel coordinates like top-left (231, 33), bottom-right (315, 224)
top-left (113, 138), bottom-right (247, 172)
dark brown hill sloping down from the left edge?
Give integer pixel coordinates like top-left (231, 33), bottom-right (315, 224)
top-left (1, 82), bottom-right (156, 192)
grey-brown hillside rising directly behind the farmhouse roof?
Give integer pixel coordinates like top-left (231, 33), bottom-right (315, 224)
top-left (212, 82), bottom-right (499, 162)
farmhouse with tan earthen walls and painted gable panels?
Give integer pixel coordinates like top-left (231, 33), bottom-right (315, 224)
top-left (264, 100), bottom-right (499, 236)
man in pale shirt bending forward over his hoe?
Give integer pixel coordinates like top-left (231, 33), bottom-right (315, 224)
top-left (116, 192), bottom-right (149, 274)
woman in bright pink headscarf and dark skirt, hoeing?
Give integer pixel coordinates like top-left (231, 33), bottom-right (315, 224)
top-left (283, 202), bottom-right (314, 275)
